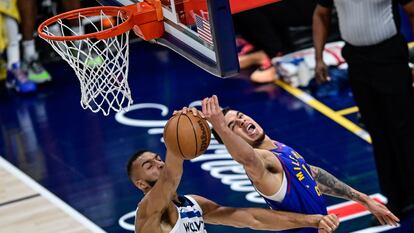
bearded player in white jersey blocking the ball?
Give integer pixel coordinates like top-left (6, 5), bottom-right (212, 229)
top-left (127, 108), bottom-right (339, 233)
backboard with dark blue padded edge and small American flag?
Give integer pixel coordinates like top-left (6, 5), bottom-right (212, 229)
top-left (97, 0), bottom-right (239, 78)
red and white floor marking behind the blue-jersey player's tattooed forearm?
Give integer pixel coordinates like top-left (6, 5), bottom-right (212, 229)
top-left (328, 193), bottom-right (387, 221)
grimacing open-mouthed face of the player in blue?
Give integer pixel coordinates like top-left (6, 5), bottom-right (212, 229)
top-left (224, 110), bottom-right (265, 147)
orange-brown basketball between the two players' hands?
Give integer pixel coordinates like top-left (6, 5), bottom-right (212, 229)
top-left (164, 111), bottom-right (211, 160)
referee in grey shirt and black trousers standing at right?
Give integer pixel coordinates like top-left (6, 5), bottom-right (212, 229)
top-left (313, 0), bottom-right (414, 217)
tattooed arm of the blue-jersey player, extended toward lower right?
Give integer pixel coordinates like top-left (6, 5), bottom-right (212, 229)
top-left (310, 166), bottom-right (400, 225)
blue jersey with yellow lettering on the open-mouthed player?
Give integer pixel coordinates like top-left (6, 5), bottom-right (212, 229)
top-left (262, 141), bottom-right (327, 233)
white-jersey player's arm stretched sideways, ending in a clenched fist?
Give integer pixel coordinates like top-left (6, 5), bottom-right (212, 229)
top-left (192, 195), bottom-right (339, 232)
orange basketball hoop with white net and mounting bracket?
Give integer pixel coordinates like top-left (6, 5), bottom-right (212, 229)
top-left (38, 0), bottom-right (164, 116)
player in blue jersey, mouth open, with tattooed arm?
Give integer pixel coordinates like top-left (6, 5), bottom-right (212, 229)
top-left (202, 95), bottom-right (399, 232)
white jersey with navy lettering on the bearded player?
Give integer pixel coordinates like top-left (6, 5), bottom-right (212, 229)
top-left (170, 196), bottom-right (207, 233)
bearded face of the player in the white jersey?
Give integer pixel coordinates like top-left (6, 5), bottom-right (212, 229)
top-left (135, 152), bottom-right (165, 187)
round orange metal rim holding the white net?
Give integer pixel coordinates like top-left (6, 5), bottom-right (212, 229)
top-left (37, 6), bottom-right (134, 41)
